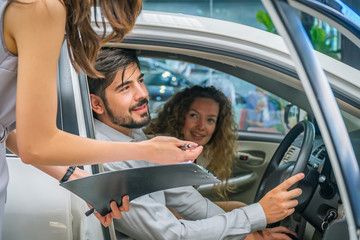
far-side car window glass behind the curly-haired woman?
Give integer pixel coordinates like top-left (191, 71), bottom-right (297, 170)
top-left (139, 57), bottom-right (306, 134)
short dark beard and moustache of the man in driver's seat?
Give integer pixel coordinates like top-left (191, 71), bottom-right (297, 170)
top-left (104, 98), bottom-right (151, 128)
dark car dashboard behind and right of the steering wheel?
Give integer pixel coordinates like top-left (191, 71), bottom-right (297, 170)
top-left (281, 135), bottom-right (345, 234)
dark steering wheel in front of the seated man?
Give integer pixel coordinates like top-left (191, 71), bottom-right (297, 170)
top-left (255, 121), bottom-right (315, 205)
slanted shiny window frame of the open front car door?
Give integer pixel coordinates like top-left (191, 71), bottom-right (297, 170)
top-left (262, 0), bottom-right (360, 236)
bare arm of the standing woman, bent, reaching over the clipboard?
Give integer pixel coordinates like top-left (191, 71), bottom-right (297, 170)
top-left (4, 0), bottom-right (202, 166)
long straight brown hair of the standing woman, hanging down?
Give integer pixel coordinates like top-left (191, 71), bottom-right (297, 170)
top-left (62, 0), bottom-right (142, 77)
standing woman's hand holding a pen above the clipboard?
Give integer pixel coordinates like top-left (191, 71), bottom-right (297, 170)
top-left (139, 137), bottom-right (202, 164)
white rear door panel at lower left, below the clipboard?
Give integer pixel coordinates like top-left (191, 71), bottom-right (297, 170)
top-left (3, 157), bottom-right (72, 240)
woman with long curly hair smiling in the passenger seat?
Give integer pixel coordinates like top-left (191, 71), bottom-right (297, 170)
top-left (145, 85), bottom-right (244, 211)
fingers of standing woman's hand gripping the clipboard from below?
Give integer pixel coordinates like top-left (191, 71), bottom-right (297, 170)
top-left (88, 196), bottom-right (130, 227)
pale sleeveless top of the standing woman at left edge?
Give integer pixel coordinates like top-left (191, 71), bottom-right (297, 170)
top-left (0, 0), bottom-right (18, 236)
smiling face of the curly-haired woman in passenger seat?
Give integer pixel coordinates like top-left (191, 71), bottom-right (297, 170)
top-left (183, 98), bottom-right (219, 145)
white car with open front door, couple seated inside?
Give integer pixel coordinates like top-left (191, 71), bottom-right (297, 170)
top-left (3, 0), bottom-right (360, 240)
